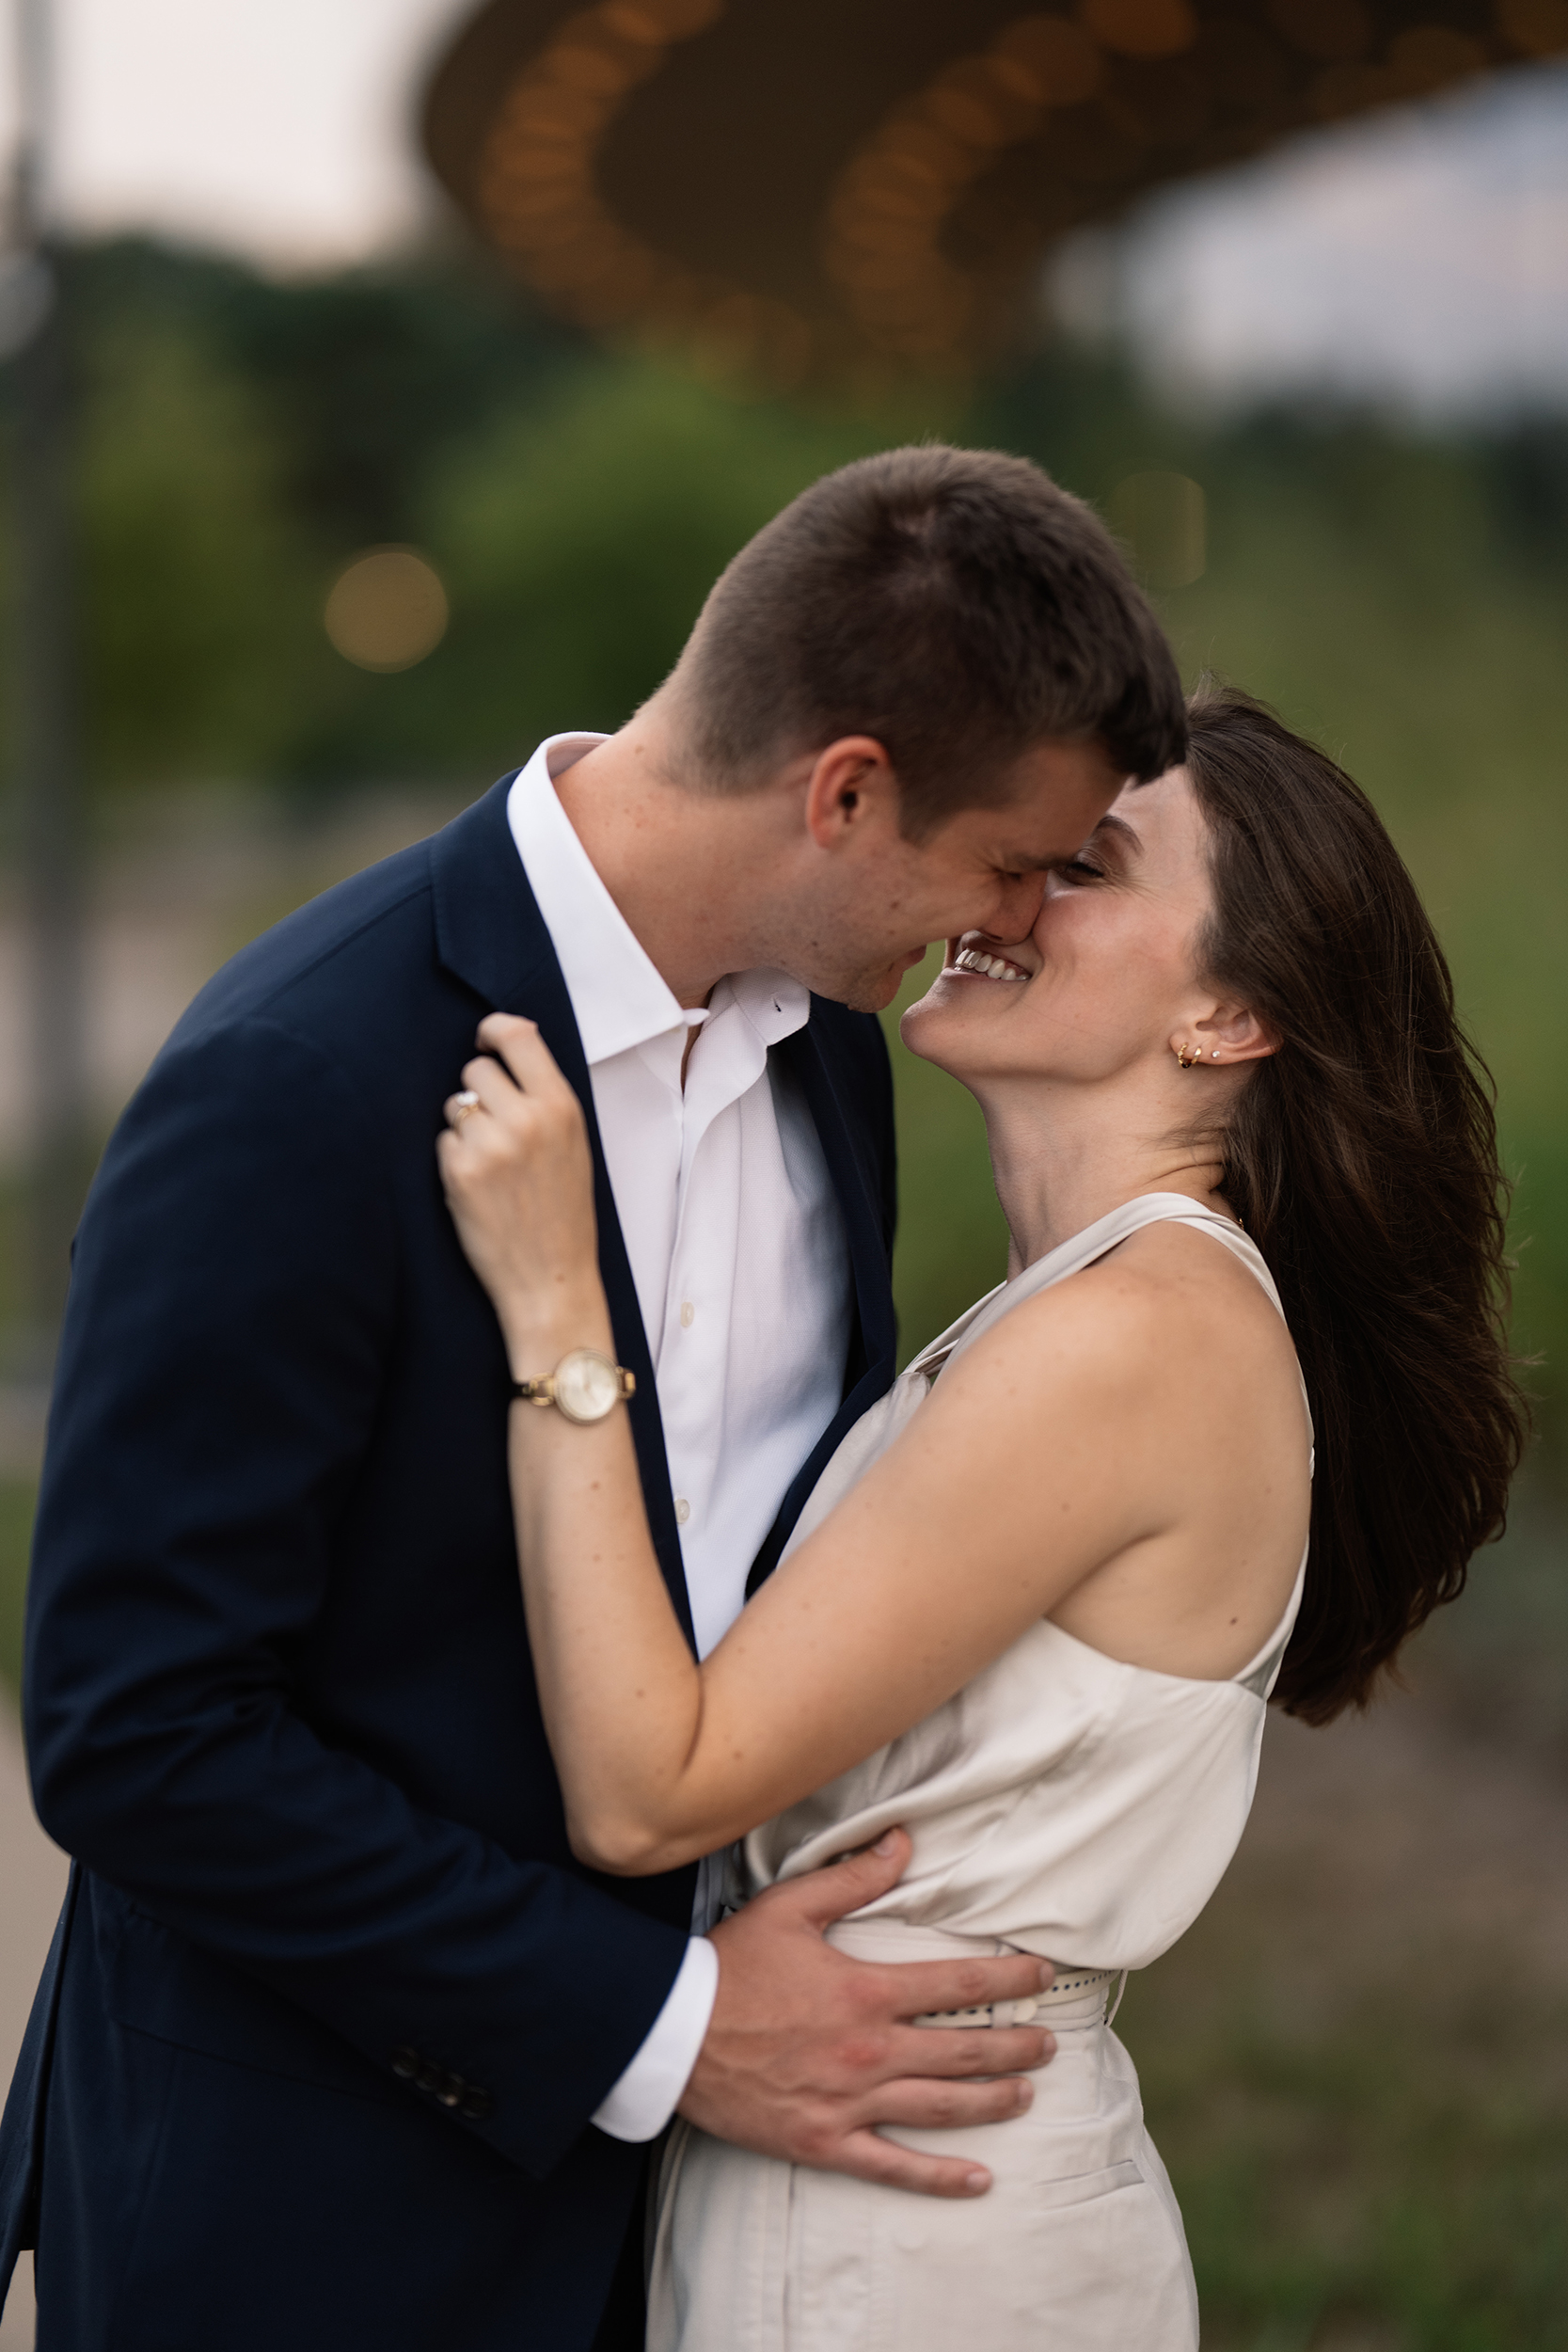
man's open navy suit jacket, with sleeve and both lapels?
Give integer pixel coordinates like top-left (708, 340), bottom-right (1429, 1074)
top-left (0, 779), bottom-right (894, 2352)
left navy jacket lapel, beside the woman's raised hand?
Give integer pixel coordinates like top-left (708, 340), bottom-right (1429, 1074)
top-left (430, 771), bottom-right (693, 1642)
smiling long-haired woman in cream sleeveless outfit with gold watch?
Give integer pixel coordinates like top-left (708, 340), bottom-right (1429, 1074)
top-left (442, 694), bottom-right (1519, 2352)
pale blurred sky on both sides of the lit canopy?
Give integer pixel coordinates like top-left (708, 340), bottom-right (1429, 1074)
top-left (0, 0), bottom-right (1568, 414)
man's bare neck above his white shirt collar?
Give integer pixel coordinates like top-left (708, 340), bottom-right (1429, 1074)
top-left (555, 718), bottom-right (771, 1009)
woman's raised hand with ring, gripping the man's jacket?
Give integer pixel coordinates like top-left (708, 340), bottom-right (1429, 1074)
top-left (435, 1014), bottom-right (602, 1364)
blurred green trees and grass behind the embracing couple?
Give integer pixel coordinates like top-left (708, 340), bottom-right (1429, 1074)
top-left (0, 229), bottom-right (1568, 2352)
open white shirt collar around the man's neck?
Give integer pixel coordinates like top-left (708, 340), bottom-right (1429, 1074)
top-left (505, 734), bottom-right (811, 1068)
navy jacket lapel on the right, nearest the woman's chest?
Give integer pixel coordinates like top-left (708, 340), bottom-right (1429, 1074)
top-left (745, 997), bottom-right (898, 1599)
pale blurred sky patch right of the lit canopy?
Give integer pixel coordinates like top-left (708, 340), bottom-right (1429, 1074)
top-left (1100, 64), bottom-right (1568, 414)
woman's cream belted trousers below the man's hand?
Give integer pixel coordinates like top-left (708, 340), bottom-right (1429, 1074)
top-left (649, 1919), bottom-right (1199, 2352)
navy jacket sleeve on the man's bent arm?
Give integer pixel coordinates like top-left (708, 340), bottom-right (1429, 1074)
top-left (25, 1019), bottom-right (687, 2173)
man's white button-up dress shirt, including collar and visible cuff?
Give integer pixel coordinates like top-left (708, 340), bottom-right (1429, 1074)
top-left (508, 734), bottom-right (851, 2140)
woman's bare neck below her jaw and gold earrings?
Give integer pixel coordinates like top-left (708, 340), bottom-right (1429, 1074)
top-left (975, 1080), bottom-right (1225, 1275)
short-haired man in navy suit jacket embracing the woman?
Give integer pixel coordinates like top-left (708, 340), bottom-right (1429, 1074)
top-left (0, 447), bottom-right (1182, 2352)
